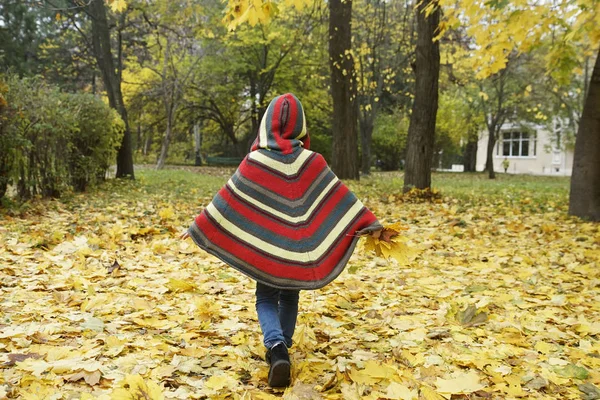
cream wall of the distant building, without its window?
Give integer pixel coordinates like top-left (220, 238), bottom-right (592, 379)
top-left (476, 125), bottom-right (573, 176)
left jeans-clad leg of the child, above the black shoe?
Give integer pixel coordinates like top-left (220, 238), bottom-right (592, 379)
top-left (256, 282), bottom-right (286, 349)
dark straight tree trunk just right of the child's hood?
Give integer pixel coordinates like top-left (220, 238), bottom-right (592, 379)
top-left (329, 0), bottom-right (359, 179)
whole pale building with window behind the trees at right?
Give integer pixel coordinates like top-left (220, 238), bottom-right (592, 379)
top-left (476, 124), bottom-right (573, 176)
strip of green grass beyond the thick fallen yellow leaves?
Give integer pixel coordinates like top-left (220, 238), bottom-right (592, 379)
top-left (0, 167), bottom-right (570, 216)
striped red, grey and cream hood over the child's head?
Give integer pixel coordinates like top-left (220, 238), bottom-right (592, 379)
top-left (251, 93), bottom-right (310, 154)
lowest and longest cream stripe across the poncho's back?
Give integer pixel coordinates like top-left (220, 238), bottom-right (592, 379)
top-left (206, 199), bottom-right (363, 262)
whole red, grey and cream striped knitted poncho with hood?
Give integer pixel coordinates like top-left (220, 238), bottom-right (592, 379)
top-left (189, 94), bottom-right (382, 289)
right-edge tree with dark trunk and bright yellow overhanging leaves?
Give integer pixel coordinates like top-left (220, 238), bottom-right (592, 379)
top-left (440, 0), bottom-right (600, 221)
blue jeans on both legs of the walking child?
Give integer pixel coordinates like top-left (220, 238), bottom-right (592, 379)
top-left (256, 282), bottom-right (300, 349)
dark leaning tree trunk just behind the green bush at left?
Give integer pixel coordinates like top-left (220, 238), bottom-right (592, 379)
top-left (88, 0), bottom-right (134, 179)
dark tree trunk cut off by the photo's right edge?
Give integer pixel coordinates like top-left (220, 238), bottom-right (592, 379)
top-left (569, 52), bottom-right (600, 221)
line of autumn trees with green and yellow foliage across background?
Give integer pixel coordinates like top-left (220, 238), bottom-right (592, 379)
top-left (0, 0), bottom-right (598, 219)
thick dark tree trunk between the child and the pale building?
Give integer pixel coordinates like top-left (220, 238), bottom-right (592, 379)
top-left (403, 1), bottom-right (440, 192)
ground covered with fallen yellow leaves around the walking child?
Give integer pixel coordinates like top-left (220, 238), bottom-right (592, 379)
top-left (0, 169), bottom-right (600, 400)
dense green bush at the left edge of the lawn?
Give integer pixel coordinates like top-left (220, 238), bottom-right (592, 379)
top-left (0, 75), bottom-right (122, 200)
